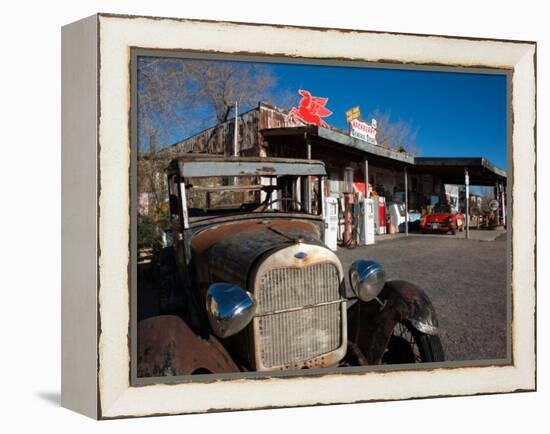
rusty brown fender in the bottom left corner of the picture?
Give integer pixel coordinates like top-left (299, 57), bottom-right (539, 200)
top-left (137, 315), bottom-right (240, 377)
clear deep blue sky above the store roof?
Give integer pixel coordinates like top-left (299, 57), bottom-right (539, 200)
top-left (140, 57), bottom-right (507, 169)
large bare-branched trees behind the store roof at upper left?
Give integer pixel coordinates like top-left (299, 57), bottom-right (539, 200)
top-left (138, 57), bottom-right (289, 153)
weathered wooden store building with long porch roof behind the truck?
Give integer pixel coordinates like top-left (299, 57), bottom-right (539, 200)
top-left (158, 103), bottom-right (507, 236)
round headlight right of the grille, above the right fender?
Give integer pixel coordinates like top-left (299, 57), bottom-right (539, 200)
top-left (349, 259), bottom-right (386, 301)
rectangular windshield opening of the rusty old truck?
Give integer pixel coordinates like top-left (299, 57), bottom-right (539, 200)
top-left (184, 175), bottom-right (321, 221)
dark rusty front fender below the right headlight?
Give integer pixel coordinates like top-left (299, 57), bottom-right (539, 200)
top-left (348, 280), bottom-right (439, 365)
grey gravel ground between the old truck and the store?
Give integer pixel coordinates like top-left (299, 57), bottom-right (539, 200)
top-left (337, 233), bottom-right (507, 361)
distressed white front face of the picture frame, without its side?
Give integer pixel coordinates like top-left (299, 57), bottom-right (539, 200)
top-left (88, 15), bottom-right (535, 418)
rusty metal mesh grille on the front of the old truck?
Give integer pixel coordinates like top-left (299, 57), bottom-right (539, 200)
top-left (256, 263), bottom-right (342, 368)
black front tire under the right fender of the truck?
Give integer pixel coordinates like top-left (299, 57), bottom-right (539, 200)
top-left (382, 321), bottom-right (445, 364)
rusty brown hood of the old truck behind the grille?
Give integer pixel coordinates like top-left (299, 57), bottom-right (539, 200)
top-left (191, 219), bottom-right (323, 291)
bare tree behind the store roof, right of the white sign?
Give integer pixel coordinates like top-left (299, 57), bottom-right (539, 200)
top-left (369, 109), bottom-right (420, 155)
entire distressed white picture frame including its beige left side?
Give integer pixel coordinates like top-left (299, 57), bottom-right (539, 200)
top-left (62, 14), bottom-right (536, 419)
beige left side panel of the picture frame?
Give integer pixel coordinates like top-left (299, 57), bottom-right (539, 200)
top-left (61, 16), bottom-right (98, 418)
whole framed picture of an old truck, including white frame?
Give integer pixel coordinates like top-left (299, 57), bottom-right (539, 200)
top-left (62, 14), bottom-right (536, 419)
